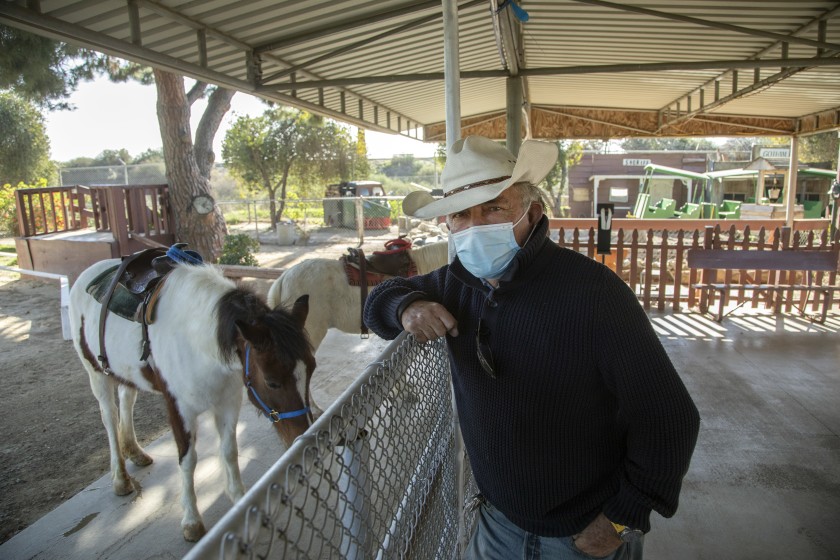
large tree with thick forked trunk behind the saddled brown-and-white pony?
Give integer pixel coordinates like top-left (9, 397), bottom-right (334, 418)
top-left (0, 27), bottom-right (236, 261)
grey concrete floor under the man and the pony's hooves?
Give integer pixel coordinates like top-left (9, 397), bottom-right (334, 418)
top-left (0, 309), bottom-right (840, 560)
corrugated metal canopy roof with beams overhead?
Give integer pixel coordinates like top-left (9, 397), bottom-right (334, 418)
top-left (0, 0), bottom-right (840, 141)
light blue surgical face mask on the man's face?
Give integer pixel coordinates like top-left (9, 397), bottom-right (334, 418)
top-left (451, 210), bottom-right (528, 278)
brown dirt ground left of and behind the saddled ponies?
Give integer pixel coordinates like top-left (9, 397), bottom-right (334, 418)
top-left (0, 226), bottom-right (418, 542)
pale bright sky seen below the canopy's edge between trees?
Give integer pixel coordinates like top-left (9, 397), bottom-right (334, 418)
top-left (44, 78), bottom-right (436, 161)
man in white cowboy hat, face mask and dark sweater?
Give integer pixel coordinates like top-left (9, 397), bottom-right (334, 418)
top-left (365, 136), bottom-right (700, 560)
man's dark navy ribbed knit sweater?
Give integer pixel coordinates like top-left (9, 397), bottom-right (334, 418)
top-left (365, 218), bottom-right (700, 537)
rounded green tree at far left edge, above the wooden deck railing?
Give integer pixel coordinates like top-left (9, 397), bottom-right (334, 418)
top-left (0, 93), bottom-right (55, 185)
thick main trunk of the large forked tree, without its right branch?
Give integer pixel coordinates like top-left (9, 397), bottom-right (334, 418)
top-left (154, 70), bottom-right (230, 262)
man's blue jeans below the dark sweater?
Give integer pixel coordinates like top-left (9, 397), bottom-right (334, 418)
top-left (464, 502), bottom-right (644, 560)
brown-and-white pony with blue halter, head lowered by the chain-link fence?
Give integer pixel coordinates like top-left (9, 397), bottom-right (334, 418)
top-left (70, 259), bottom-right (315, 541)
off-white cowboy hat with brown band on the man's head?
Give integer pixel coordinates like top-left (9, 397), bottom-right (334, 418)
top-left (403, 136), bottom-right (559, 218)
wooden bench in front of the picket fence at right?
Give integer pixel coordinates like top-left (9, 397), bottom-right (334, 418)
top-left (687, 249), bottom-right (840, 323)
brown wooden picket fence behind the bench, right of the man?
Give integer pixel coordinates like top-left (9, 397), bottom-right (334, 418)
top-left (549, 219), bottom-right (840, 318)
